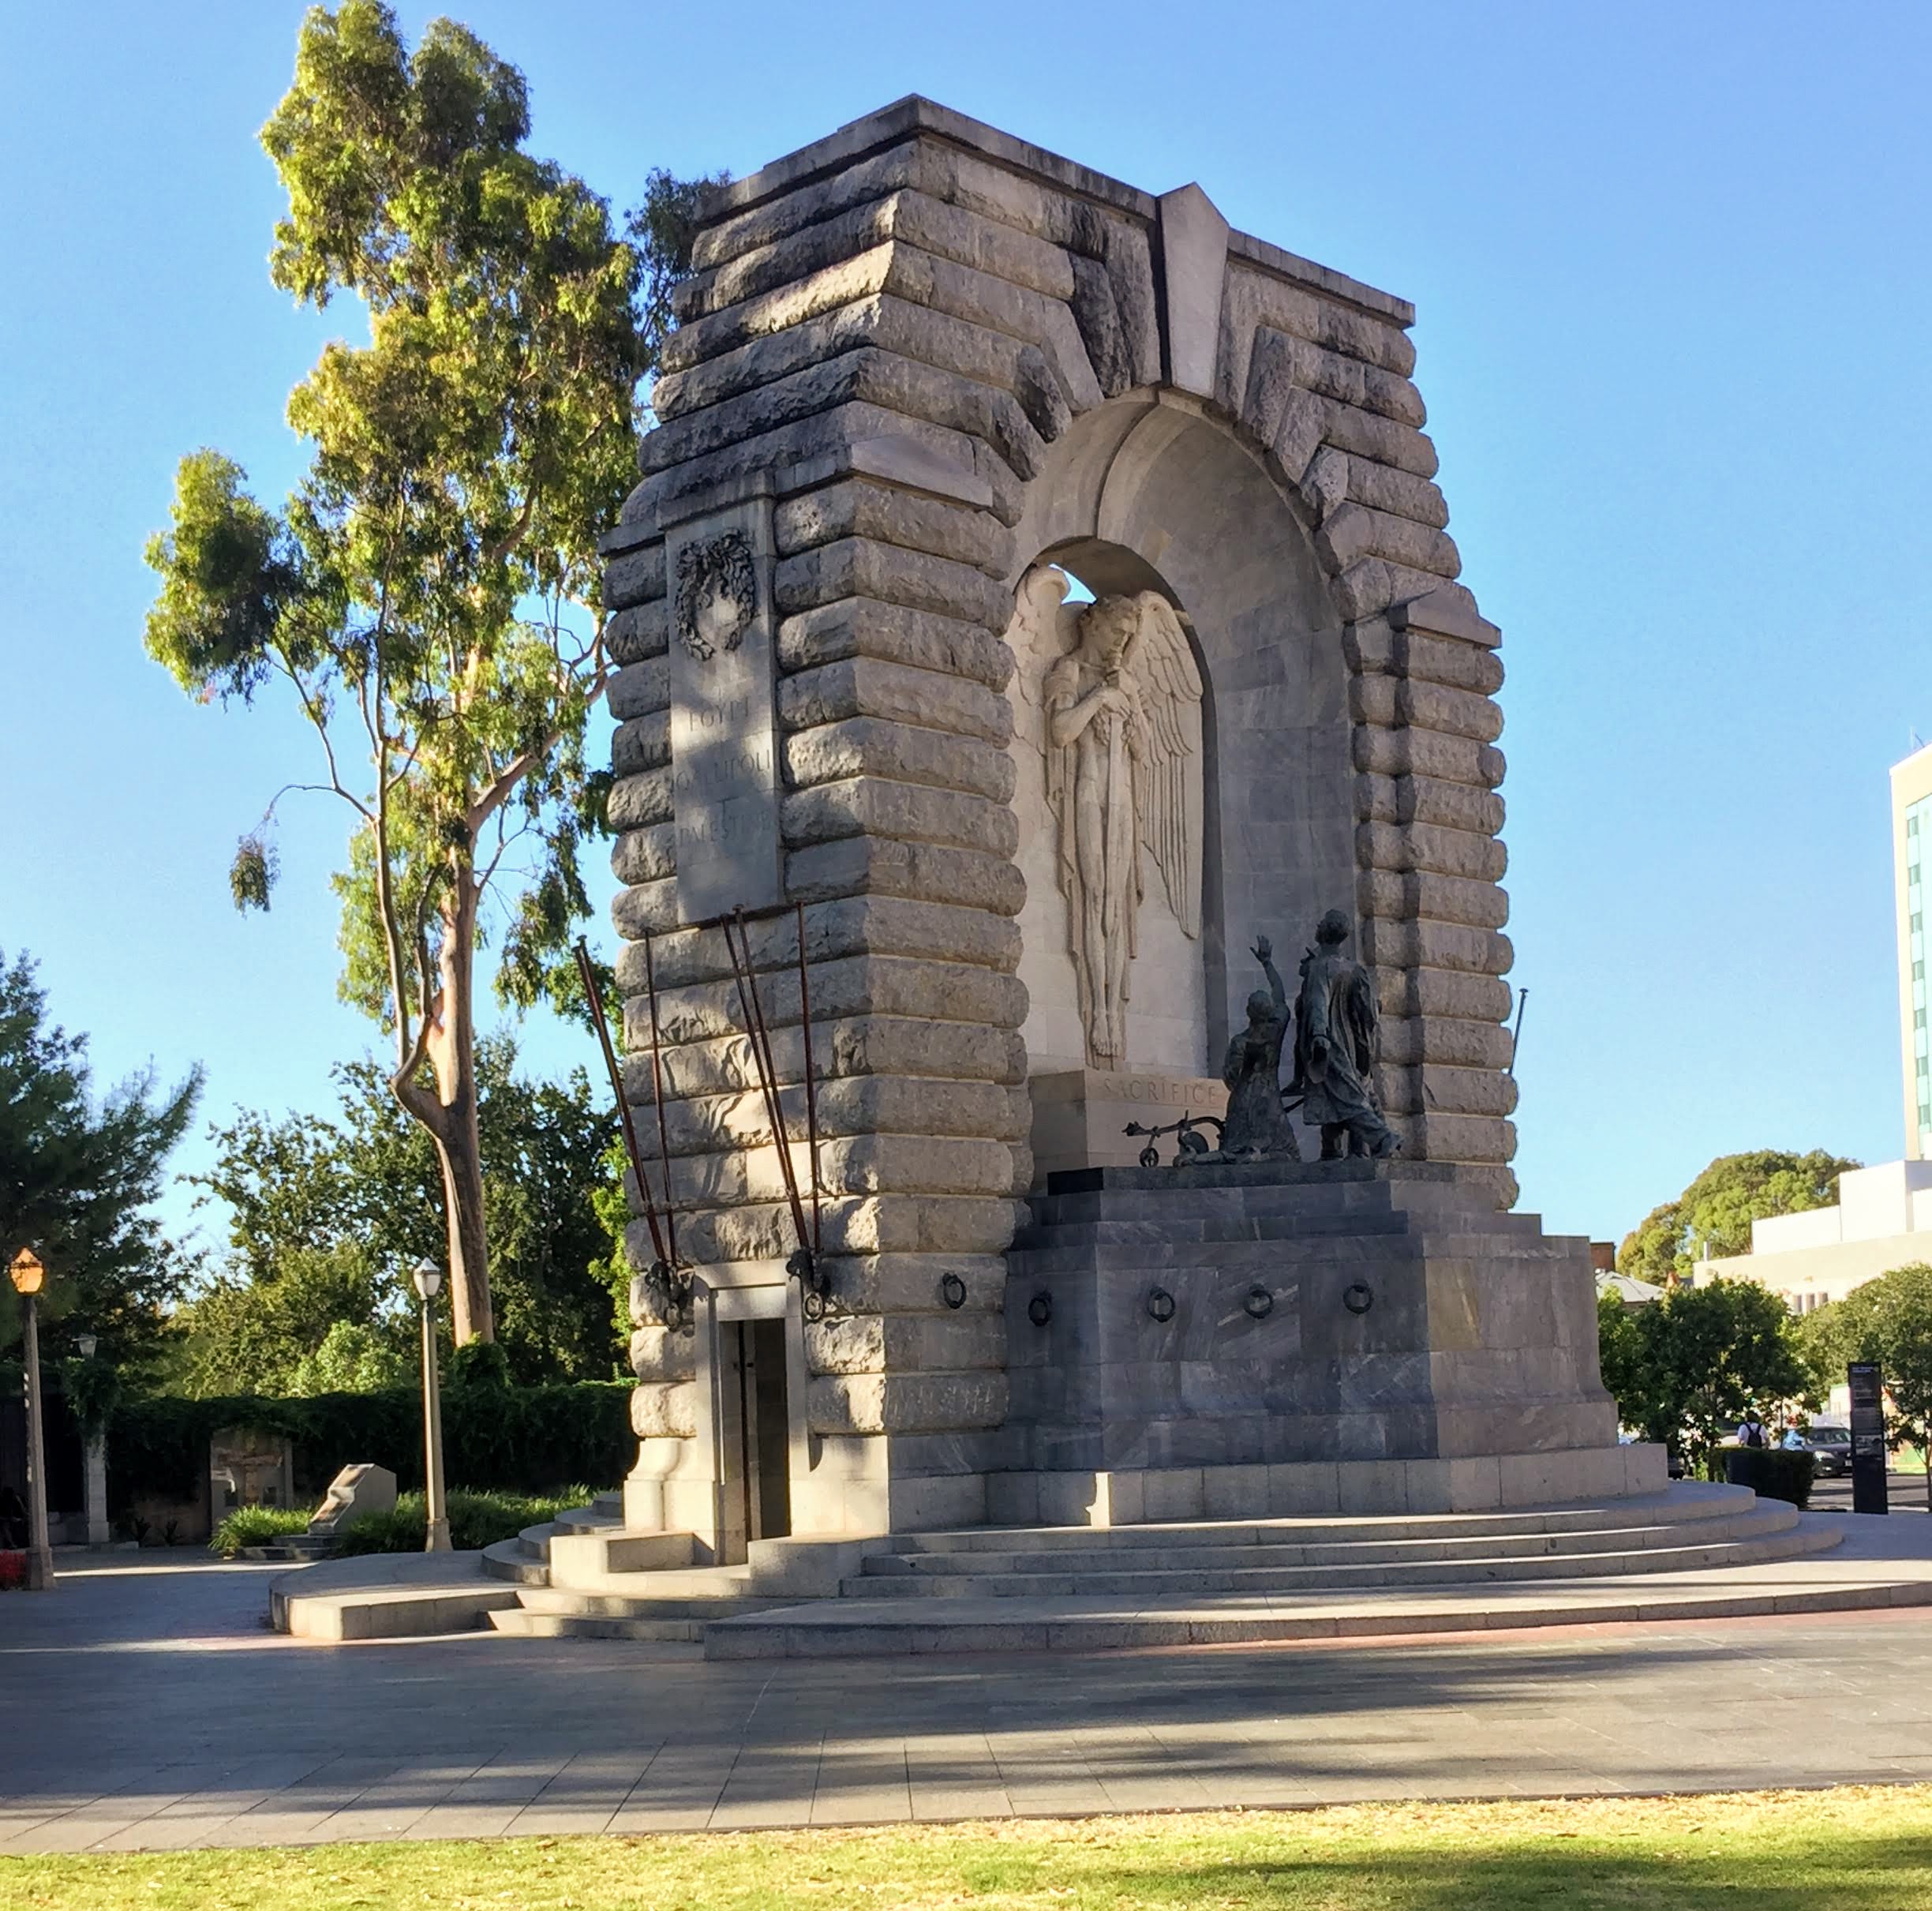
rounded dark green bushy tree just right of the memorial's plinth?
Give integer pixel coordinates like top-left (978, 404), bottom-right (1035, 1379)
top-left (1597, 1281), bottom-right (1814, 1465)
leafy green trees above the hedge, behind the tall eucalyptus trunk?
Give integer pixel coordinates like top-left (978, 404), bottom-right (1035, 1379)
top-left (184, 1038), bottom-right (622, 1395)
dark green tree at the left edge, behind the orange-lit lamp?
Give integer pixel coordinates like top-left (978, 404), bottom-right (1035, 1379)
top-left (0, 954), bottom-right (201, 1380)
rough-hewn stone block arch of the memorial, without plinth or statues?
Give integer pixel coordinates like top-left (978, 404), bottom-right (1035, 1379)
top-left (603, 99), bottom-right (1515, 1544)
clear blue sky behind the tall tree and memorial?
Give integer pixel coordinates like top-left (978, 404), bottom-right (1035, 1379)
top-left (0, 0), bottom-right (1932, 1237)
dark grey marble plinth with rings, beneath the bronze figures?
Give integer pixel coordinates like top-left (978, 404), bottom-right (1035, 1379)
top-left (989, 1161), bottom-right (1664, 1524)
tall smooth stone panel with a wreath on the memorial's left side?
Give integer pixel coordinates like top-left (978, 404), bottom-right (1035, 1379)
top-left (667, 519), bottom-right (782, 922)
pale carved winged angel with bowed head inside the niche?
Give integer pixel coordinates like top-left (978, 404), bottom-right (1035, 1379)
top-left (1017, 566), bottom-right (1202, 1069)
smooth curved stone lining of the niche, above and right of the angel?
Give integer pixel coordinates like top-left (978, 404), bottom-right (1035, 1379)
top-left (1009, 392), bottom-right (1354, 1074)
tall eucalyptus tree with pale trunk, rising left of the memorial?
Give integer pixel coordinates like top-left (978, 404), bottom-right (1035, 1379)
top-left (147, 0), bottom-right (710, 1341)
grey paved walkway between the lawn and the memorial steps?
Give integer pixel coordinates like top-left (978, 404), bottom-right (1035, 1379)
top-left (0, 1536), bottom-right (1932, 1851)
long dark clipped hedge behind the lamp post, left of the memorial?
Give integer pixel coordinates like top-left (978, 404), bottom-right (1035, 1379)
top-left (108, 1380), bottom-right (638, 1513)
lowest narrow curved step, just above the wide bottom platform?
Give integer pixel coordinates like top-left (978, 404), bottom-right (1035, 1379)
top-left (838, 1531), bottom-right (1836, 1600)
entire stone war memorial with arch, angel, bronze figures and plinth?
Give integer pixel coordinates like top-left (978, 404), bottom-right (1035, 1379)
top-left (603, 99), bottom-right (1665, 1565)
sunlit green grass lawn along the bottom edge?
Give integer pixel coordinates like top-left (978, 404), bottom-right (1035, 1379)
top-left (0, 1785), bottom-right (1932, 1911)
